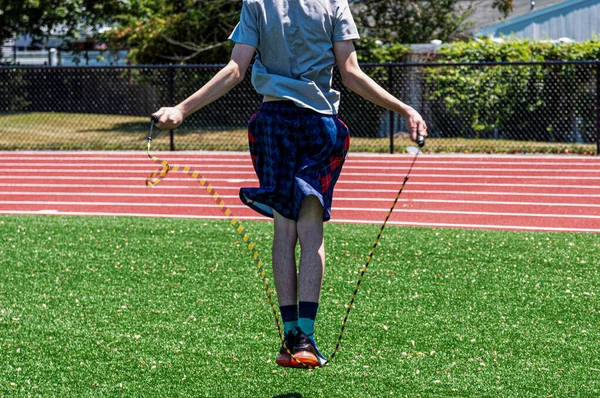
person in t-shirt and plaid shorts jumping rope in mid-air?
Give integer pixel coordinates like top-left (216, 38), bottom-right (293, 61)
top-left (153, 0), bottom-right (427, 367)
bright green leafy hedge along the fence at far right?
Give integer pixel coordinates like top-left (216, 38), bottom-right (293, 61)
top-left (424, 40), bottom-right (600, 142)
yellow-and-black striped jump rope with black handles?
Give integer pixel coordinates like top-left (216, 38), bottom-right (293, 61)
top-left (146, 115), bottom-right (425, 369)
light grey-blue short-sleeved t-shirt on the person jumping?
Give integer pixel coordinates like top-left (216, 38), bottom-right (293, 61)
top-left (229, 0), bottom-right (359, 115)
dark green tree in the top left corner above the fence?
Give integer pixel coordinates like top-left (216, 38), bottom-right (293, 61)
top-left (0, 0), bottom-right (131, 42)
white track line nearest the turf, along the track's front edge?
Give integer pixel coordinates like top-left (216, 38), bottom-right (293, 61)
top-left (3, 210), bottom-right (600, 233)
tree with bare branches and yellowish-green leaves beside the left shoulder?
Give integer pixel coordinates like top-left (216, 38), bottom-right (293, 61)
top-left (105, 0), bottom-right (242, 64)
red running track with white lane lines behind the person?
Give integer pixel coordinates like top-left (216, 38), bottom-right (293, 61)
top-left (0, 151), bottom-right (600, 233)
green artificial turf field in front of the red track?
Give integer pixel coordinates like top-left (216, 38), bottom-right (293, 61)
top-left (0, 216), bottom-right (600, 398)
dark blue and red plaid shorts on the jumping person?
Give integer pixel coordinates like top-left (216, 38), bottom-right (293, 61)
top-left (240, 101), bottom-right (350, 221)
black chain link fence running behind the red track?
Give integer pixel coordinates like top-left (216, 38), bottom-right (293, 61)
top-left (0, 61), bottom-right (600, 155)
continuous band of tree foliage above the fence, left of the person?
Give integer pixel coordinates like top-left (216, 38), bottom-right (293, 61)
top-left (0, 0), bottom-right (242, 63)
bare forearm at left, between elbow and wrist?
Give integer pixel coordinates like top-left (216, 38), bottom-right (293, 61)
top-left (176, 61), bottom-right (244, 118)
